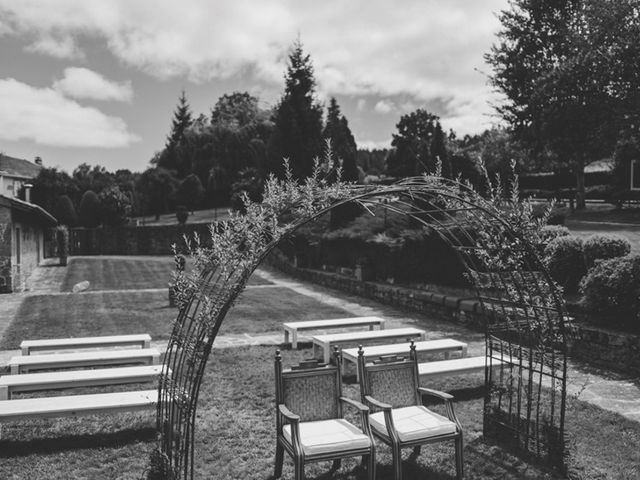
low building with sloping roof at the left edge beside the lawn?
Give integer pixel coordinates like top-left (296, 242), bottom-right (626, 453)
top-left (0, 195), bottom-right (58, 293)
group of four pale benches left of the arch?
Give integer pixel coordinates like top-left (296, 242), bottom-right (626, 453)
top-left (0, 334), bottom-right (162, 423)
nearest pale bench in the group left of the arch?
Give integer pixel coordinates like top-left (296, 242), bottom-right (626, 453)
top-left (0, 389), bottom-right (158, 423)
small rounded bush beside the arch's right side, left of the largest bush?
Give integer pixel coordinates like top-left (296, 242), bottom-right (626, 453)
top-left (544, 235), bottom-right (586, 292)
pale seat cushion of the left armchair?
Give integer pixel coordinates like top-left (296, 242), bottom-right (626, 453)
top-left (282, 418), bottom-right (371, 455)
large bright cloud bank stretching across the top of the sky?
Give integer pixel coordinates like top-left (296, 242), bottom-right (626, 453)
top-left (0, 0), bottom-right (508, 133)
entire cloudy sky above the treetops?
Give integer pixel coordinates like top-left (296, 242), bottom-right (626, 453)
top-left (0, 0), bottom-right (507, 172)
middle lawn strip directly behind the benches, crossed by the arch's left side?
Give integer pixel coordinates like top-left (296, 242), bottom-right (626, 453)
top-left (0, 286), bottom-right (352, 350)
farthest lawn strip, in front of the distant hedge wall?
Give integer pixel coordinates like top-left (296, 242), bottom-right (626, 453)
top-left (61, 256), bottom-right (270, 292)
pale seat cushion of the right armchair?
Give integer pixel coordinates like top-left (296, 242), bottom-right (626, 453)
top-left (369, 405), bottom-right (456, 442)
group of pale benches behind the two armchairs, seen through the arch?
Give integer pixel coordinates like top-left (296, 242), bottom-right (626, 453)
top-left (283, 317), bottom-right (492, 380)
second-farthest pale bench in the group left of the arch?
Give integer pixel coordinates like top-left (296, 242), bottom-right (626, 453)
top-left (9, 348), bottom-right (160, 375)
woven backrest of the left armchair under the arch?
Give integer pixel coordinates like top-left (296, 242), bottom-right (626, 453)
top-left (275, 350), bottom-right (342, 422)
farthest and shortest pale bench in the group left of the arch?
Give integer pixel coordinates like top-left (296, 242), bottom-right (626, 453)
top-left (20, 333), bottom-right (151, 355)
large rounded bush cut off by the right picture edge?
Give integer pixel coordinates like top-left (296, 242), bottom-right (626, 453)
top-left (580, 255), bottom-right (640, 326)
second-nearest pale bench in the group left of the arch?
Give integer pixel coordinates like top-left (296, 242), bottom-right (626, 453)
top-left (0, 365), bottom-right (162, 400)
